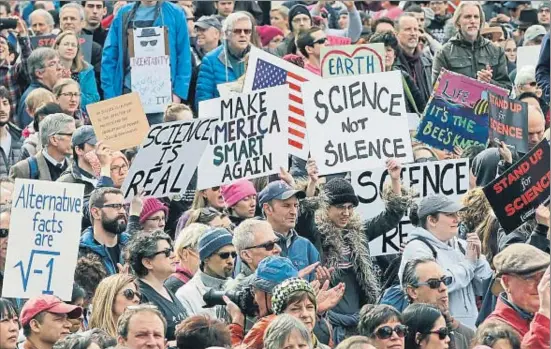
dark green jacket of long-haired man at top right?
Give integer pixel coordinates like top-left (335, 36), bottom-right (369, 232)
top-left (432, 33), bottom-right (512, 90)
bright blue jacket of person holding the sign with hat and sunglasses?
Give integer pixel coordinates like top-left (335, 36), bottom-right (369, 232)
top-left (101, 1), bottom-right (191, 99)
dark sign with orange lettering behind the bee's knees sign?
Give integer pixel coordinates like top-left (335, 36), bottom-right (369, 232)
top-left (488, 91), bottom-right (529, 154)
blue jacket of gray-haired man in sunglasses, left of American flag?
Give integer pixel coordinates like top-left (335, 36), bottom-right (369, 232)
top-left (195, 44), bottom-right (239, 104)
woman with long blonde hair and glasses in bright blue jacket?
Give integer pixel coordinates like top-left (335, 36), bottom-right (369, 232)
top-left (54, 31), bottom-right (99, 111)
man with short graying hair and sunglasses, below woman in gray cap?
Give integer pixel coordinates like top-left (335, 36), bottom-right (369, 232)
top-left (402, 258), bottom-right (474, 349)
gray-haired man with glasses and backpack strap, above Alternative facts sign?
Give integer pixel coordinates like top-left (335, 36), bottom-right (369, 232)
top-left (10, 113), bottom-right (75, 181)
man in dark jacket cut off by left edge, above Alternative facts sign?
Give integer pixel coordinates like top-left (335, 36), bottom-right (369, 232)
top-left (0, 86), bottom-right (23, 177)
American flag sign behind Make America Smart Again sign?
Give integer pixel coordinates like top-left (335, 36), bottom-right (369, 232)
top-left (243, 47), bottom-right (321, 160)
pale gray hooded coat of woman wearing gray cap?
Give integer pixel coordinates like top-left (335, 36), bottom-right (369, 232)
top-left (398, 227), bottom-right (493, 328)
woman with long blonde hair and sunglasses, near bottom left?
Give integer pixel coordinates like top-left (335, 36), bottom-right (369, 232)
top-left (89, 274), bottom-right (141, 338)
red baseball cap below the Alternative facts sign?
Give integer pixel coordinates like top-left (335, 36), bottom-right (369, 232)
top-left (20, 295), bottom-right (82, 326)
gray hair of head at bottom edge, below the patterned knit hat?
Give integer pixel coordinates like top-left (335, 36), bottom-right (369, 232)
top-left (264, 314), bottom-right (313, 349)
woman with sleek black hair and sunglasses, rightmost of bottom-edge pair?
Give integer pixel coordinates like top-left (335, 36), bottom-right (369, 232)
top-left (402, 303), bottom-right (451, 349)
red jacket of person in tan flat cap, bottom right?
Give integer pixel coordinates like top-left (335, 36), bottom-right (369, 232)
top-left (485, 297), bottom-right (550, 349)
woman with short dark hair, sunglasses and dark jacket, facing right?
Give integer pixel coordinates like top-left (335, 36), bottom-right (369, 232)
top-left (127, 230), bottom-right (188, 341)
